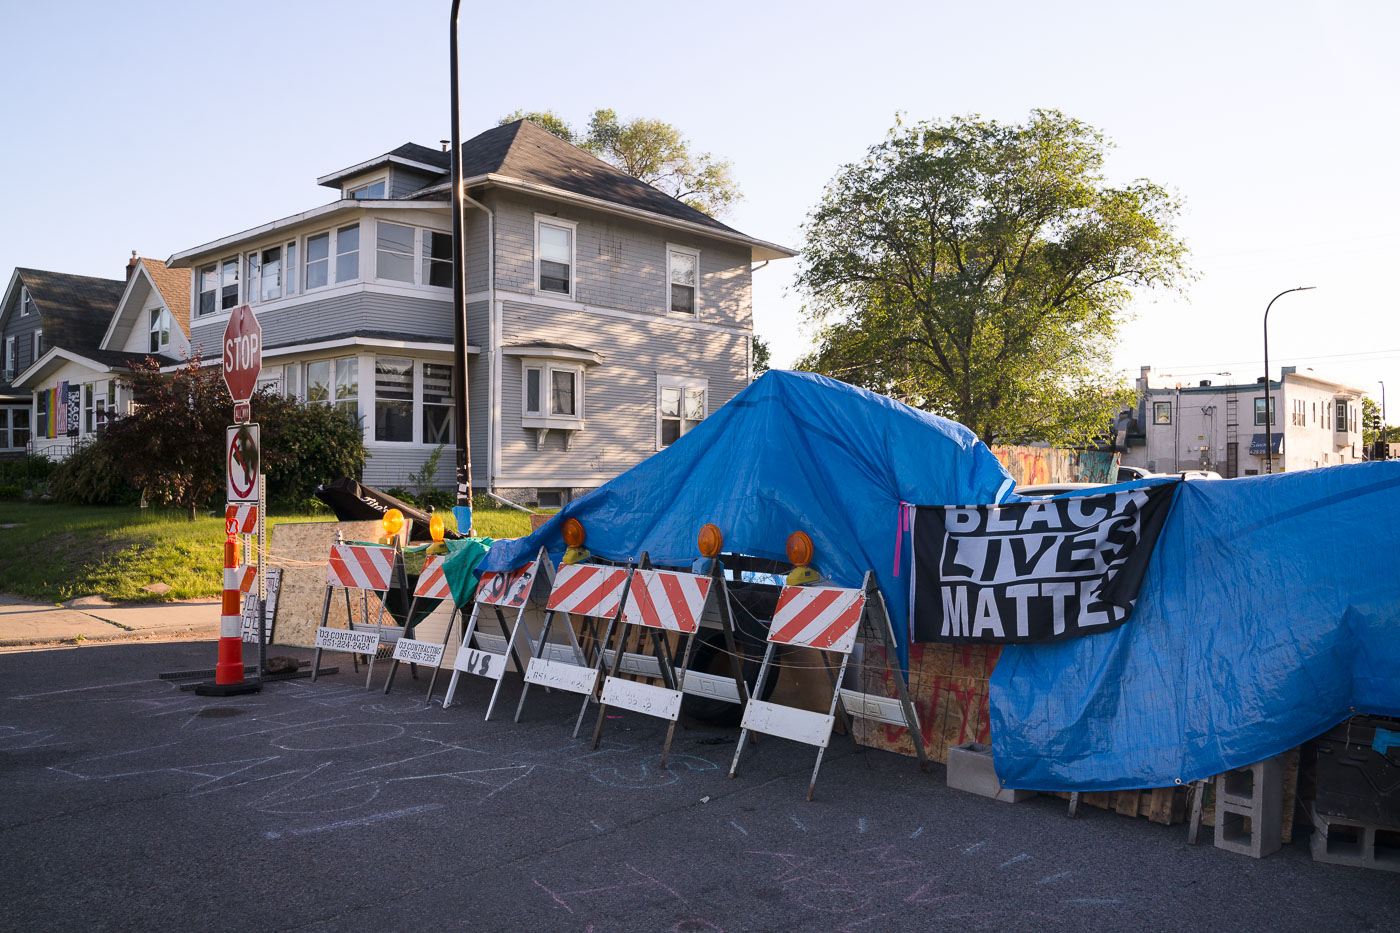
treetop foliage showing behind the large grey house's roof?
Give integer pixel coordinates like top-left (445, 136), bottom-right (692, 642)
top-left (500, 109), bottom-right (742, 216)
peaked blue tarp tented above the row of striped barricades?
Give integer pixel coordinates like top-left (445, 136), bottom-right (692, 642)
top-left (482, 371), bottom-right (1012, 654)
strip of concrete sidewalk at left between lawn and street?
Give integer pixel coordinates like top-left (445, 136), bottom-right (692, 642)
top-left (0, 594), bottom-right (220, 649)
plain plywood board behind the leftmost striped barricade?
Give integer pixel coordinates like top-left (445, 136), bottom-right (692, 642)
top-left (267, 521), bottom-right (400, 647)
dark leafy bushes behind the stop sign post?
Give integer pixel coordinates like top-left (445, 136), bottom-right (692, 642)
top-left (99, 356), bottom-right (365, 518)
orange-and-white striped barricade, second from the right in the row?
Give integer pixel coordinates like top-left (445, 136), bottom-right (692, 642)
top-left (594, 556), bottom-right (749, 768)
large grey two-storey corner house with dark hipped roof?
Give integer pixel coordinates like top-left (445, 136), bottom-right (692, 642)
top-left (169, 120), bottom-right (794, 504)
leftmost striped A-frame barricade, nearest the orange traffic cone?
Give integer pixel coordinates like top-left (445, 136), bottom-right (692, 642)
top-left (311, 532), bottom-right (405, 689)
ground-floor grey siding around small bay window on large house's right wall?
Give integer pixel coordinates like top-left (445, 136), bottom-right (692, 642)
top-left (496, 300), bottom-right (749, 488)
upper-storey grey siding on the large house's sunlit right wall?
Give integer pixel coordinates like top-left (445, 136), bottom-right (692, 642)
top-left (484, 192), bottom-right (753, 328)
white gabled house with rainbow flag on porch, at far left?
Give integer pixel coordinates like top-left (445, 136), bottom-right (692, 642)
top-left (14, 252), bottom-right (189, 458)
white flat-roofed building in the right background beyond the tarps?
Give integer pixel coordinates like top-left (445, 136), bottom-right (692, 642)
top-left (1121, 366), bottom-right (1364, 476)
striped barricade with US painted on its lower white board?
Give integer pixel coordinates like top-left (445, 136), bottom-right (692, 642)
top-left (442, 548), bottom-right (554, 719)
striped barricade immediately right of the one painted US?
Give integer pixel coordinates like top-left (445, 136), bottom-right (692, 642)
top-left (515, 563), bottom-right (631, 735)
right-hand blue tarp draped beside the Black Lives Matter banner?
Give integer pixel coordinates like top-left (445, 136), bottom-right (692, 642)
top-left (990, 462), bottom-right (1400, 790)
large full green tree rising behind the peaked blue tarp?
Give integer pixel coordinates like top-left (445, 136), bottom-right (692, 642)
top-left (798, 111), bottom-right (1189, 445)
